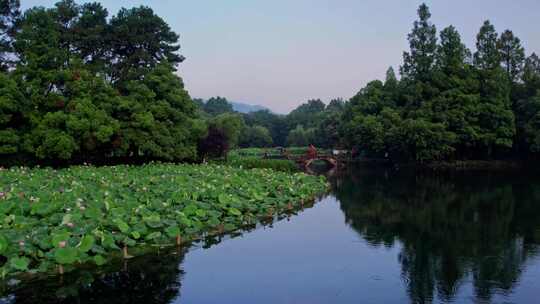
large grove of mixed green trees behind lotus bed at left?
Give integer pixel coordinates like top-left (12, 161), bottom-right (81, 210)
top-left (0, 0), bottom-right (201, 164)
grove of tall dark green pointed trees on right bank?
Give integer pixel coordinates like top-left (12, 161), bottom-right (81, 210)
top-left (337, 4), bottom-right (540, 161)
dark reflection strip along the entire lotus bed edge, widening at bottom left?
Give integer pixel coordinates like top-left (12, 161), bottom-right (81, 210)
top-left (0, 202), bottom-right (313, 304)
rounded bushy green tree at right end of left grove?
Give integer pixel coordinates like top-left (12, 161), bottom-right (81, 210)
top-left (114, 62), bottom-right (200, 160)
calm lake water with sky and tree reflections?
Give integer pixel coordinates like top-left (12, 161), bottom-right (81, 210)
top-left (0, 168), bottom-right (540, 304)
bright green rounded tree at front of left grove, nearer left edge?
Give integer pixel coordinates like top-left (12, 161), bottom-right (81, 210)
top-left (24, 67), bottom-right (120, 161)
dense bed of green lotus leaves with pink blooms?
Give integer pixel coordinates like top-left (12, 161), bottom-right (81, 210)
top-left (0, 164), bottom-right (328, 279)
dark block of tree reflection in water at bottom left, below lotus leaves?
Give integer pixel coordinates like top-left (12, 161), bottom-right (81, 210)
top-left (0, 251), bottom-right (188, 304)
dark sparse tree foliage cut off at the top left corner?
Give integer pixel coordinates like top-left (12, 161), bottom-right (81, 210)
top-left (0, 0), bottom-right (21, 71)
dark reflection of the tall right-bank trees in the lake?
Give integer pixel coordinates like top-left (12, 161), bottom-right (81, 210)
top-left (334, 171), bottom-right (540, 303)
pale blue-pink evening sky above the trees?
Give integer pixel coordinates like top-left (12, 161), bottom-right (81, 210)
top-left (21, 0), bottom-right (540, 113)
